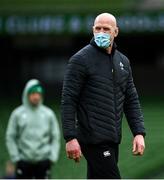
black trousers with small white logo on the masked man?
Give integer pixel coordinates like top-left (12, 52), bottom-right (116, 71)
top-left (80, 143), bottom-right (121, 179)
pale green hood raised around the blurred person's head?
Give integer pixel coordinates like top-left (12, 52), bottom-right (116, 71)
top-left (22, 79), bottom-right (43, 107)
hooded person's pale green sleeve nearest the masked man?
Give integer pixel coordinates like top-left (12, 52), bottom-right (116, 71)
top-left (49, 112), bottom-right (60, 162)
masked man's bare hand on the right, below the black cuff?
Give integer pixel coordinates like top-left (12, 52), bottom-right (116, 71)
top-left (133, 135), bottom-right (145, 156)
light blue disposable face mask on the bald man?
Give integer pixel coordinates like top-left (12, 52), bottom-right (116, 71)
top-left (94, 32), bottom-right (111, 49)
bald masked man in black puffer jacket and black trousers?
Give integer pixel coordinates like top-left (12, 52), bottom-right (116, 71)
top-left (62, 13), bottom-right (145, 179)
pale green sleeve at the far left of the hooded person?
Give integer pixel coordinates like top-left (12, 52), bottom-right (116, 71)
top-left (6, 111), bottom-right (20, 162)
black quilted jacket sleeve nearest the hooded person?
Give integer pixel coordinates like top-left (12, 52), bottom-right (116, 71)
top-left (61, 56), bottom-right (86, 141)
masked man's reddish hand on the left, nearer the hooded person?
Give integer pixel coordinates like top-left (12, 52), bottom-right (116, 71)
top-left (66, 139), bottom-right (82, 162)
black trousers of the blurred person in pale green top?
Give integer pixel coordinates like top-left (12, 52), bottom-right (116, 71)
top-left (16, 160), bottom-right (51, 179)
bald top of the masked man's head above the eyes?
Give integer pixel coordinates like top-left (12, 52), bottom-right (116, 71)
top-left (94, 13), bottom-right (117, 27)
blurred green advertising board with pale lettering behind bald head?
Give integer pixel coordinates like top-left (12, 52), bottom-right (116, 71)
top-left (0, 13), bottom-right (164, 35)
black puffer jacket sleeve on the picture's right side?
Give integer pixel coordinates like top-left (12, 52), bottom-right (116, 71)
top-left (124, 65), bottom-right (146, 136)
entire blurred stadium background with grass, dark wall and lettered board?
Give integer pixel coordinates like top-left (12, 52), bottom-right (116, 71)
top-left (0, 0), bottom-right (164, 179)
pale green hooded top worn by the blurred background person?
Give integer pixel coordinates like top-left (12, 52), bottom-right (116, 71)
top-left (6, 79), bottom-right (60, 162)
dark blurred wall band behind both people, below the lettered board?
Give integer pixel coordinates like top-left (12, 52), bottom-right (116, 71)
top-left (0, 33), bottom-right (164, 97)
